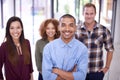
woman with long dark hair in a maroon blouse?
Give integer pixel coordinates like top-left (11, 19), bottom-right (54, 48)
top-left (0, 16), bottom-right (33, 80)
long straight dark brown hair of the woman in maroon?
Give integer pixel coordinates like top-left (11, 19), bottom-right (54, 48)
top-left (5, 16), bottom-right (30, 64)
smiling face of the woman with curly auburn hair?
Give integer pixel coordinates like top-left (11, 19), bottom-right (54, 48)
top-left (46, 23), bottom-right (56, 38)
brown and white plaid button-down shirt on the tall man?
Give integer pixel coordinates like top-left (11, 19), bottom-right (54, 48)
top-left (77, 23), bottom-right (114, 73)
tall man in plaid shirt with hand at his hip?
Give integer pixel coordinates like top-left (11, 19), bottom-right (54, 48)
top-left (77, 3), bottom-right (114, 80)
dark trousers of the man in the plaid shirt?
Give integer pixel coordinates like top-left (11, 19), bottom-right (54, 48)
top-left (85, 71), bottom-right (104, 80)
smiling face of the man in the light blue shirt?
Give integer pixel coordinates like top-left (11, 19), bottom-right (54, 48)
top-left (59, 18), bottom-right (76, 43)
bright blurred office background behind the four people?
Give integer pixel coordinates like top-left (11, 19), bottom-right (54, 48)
top-left (0, 0), bottom-right (120, 80)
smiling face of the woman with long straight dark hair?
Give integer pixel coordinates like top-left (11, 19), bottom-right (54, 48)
top-left (9, 21), bottom-right (22, 41)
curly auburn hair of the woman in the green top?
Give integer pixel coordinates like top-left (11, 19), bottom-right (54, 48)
top-left (39, 19), bottom-right (60, 40)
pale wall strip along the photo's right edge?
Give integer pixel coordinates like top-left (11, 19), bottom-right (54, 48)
top-left (109, 0), bottom-right (120, 80)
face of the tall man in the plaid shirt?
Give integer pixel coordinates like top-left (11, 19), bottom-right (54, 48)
top-left (83, 7), bottom-right (96, 24)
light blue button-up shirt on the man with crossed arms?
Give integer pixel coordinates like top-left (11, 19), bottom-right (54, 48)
top-left (42, 38), bottom-right (88, 80)
